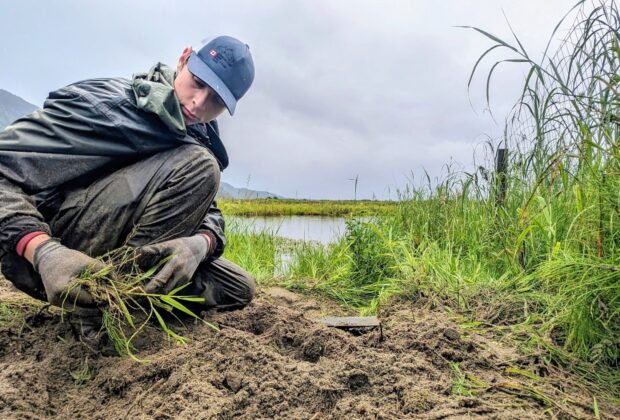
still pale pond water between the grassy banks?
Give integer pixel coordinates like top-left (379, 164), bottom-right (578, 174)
top-left (227, 216), bottom-right (346, 244)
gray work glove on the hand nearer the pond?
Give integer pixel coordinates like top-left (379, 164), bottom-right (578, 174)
top-left (138, 234), bottom-right (209, 294)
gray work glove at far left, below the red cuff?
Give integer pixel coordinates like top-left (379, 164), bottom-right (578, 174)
top-left (33, 239), bottom-right (107, 310)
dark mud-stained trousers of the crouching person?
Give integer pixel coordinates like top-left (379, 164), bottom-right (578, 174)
top-left (0, 145), bottom-right (255, 310)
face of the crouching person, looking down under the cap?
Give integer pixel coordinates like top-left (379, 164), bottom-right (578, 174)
top-left (174, 48), bottom-right (226, 125)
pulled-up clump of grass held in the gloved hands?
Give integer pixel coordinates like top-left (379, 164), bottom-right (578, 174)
top-left (63, 247), bottom-right (217, 361)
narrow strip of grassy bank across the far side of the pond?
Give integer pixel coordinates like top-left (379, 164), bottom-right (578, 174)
top-left (218, 199), bottom-right (398, 217)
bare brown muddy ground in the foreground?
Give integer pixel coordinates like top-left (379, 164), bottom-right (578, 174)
top-left (0, 280), bottom-right (620, 419)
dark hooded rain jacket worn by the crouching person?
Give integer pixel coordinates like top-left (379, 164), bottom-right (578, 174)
top-left (0, 64), bottom-right (228, 257)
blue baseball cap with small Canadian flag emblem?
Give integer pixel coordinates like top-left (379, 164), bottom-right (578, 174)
top-left (187, 36), bottom-right (254, 115)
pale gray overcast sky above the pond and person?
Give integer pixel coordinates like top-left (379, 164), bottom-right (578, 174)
top-left (0, 0), bottom-right (575, 199)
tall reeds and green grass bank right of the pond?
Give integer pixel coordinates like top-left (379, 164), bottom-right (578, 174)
top-left (224, 1), bottom-right (620, 396)
